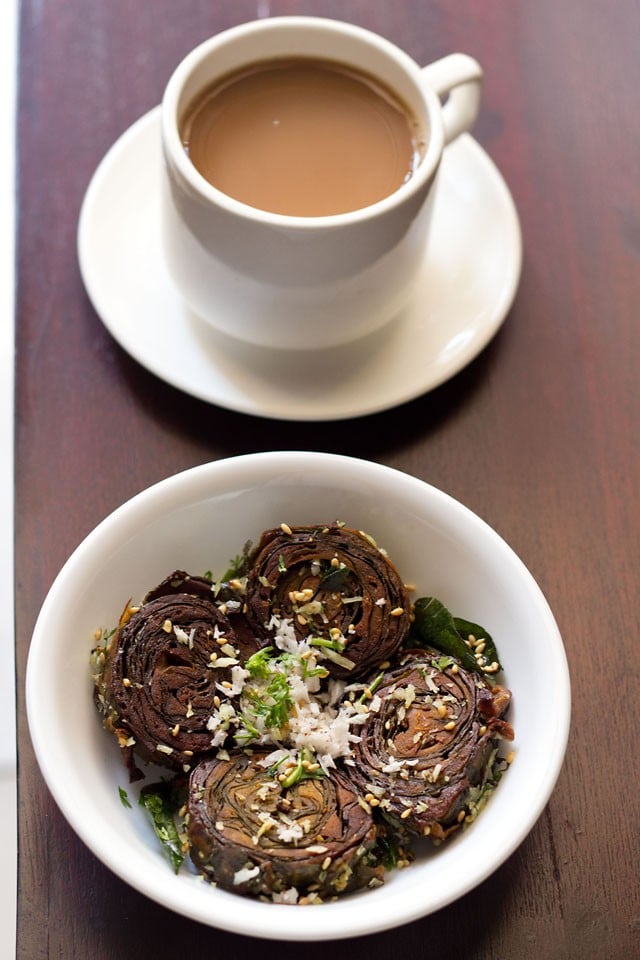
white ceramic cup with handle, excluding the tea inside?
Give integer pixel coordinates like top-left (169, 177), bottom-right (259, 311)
top-left (162, 17), bottom-right (482, 349)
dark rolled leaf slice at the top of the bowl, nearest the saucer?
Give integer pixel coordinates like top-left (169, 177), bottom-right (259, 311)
top-left (240, 523), bottom-right (411, 680)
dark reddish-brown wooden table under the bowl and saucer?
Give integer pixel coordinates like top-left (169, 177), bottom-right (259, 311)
top-left (16, 0), bottom-right (640, 960)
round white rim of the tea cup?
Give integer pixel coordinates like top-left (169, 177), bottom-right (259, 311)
top-left (161, 16), bottom-right (444, 229)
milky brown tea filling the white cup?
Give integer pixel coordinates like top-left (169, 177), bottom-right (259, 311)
top-left (180, 58), bottom-right (426, 217)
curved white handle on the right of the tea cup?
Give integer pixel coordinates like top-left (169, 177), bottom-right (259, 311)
top-left (422, 53), bottom-right (482, 144)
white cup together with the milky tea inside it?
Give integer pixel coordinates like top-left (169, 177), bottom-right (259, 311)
top-left (162, 17), bottom-right (482, 350)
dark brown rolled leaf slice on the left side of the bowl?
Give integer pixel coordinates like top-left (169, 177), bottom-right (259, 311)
top-left (94, 593), bottom-right (242, 780)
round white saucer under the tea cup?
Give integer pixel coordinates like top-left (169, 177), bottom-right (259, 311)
top-left (78, 108), bottom-right (522, 420)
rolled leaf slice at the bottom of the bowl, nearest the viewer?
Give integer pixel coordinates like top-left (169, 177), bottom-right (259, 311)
top-left (187, 751), bottom-right (383, 903)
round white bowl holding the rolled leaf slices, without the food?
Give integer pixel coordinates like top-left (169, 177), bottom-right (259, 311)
top-left (27, 452), bottom-right (570, 940)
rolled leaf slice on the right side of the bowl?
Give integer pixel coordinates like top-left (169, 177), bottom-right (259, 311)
top-left (349, 649), bottom-right (513, 840)
